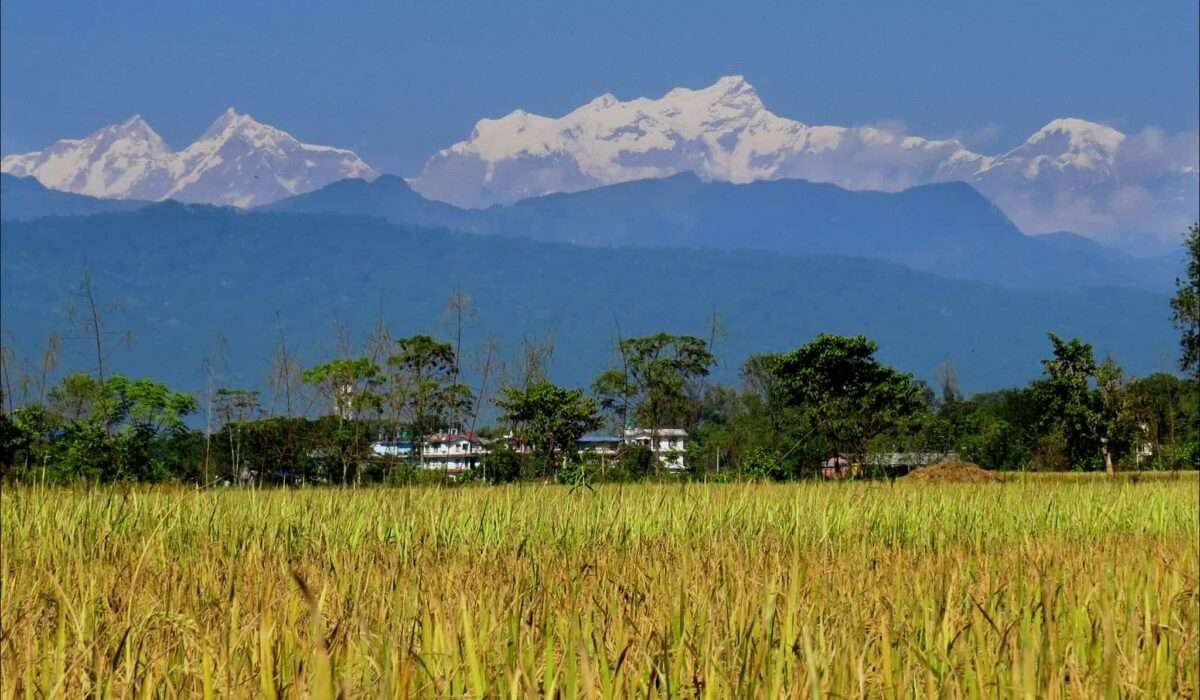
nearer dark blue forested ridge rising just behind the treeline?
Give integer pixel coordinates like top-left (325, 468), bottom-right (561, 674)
top-left (0, 203), bottom-right (1176, 401)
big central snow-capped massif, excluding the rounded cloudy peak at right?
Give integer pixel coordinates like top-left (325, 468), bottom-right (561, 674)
top-left (412, 76), bottom-right (982, 207)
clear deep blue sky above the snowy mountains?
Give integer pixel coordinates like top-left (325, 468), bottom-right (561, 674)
top-left (0, 0), bottom-right (1200, 175)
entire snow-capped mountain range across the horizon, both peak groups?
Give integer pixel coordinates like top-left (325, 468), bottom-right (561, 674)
top-left (0, 76), bottom-right (1200, 255)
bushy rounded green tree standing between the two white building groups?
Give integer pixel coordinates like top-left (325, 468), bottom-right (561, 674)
top-left (496, 381), bottom-right (604, 477)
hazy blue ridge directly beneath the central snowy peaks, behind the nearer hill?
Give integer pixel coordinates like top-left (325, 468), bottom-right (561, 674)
top-left (274, 173), bottom-right (1174, 291)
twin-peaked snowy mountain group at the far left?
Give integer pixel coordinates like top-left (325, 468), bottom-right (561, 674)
top-left (0, 107), bottom-right (378, 207)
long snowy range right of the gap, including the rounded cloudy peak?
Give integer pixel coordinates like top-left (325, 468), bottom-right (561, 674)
top-left (410, 76), bottom-right (1200, 247)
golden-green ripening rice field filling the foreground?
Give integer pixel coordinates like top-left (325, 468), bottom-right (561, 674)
top-left (0, 478), bottom-right (1200, 698)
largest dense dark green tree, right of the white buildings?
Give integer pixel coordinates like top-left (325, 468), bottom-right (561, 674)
top-left (774, 334), bottom-right (925, 470)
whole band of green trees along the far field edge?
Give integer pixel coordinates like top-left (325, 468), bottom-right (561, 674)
top-left (0, 226), bottom-right (1200, 485)
